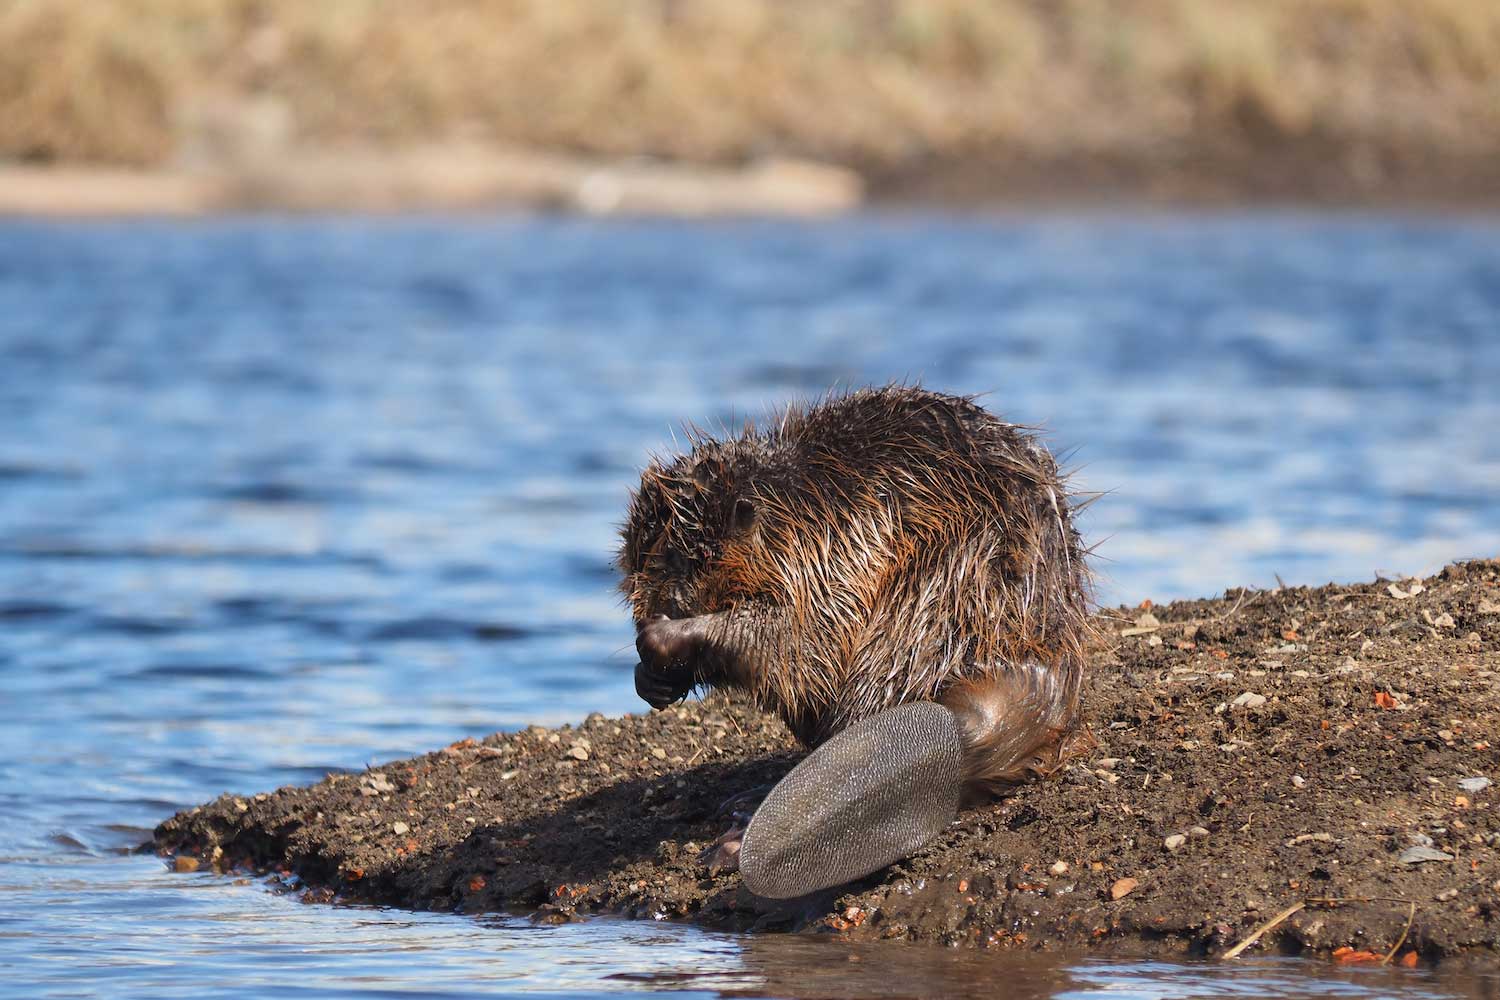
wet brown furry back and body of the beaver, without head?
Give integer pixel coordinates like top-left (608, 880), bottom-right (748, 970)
top-left (704, 387), bottom-right (1089, 744)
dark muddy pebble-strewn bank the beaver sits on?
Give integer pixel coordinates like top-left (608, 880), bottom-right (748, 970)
top-left (155, 562), bottom-right (1500, 963)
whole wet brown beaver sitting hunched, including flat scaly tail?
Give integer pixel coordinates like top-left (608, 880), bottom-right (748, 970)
top-left (620, 385), bottom-right (1092, 898)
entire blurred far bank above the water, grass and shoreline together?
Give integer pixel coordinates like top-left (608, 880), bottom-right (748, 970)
top-left (0, 0), bottom-right (1500, 216)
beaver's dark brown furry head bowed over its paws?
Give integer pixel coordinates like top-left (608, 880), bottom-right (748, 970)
top-left (620, 438), bottom-right (762, 625)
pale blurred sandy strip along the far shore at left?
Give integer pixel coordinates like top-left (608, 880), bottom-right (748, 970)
top-left (0, 145), bottom-right (864, 217)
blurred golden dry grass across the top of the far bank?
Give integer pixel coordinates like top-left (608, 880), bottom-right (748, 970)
top-left (0, 0), bottom-right (1500, 183)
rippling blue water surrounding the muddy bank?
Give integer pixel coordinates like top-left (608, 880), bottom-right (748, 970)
top-left (0, 214), bottom-right (1500, 1000)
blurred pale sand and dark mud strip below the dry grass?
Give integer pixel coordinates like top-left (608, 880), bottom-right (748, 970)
top-left (0, 144), bottom-right (1500, 217)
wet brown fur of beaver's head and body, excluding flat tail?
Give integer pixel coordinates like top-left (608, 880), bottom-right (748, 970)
top-left (620, 385), bottom-right (1091, 790)
